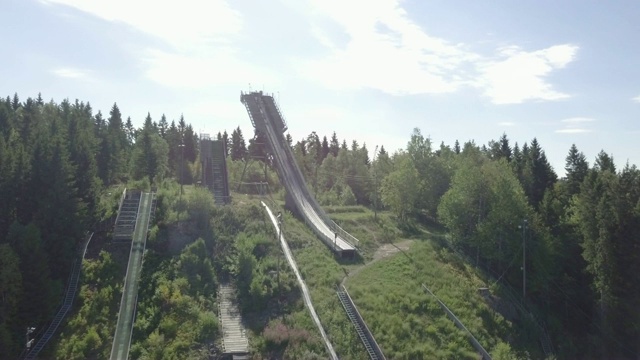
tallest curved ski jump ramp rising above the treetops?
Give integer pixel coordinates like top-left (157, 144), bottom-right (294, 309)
top-left (240, 91), bottom-right (358, 257)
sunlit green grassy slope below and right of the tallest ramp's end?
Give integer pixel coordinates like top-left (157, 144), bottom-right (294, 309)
top-left (347, 240), bottom-right (514, 359)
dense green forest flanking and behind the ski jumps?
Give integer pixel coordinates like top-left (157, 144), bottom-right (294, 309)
top-left (0, 94), bottom-right (640, 358)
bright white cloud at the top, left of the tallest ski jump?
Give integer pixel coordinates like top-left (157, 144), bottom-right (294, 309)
top-left (41, 0), bottom-right (267, 89)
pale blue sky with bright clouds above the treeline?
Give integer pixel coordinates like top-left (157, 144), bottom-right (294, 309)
top-left (0, 0), bottom-right (640, 176)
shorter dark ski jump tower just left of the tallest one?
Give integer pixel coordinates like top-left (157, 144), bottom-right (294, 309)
top-left (200, 134), bottom-right (231, 205)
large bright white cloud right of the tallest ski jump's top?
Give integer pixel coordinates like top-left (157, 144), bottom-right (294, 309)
top-left (298, 0), bottom-right (578, 104)
